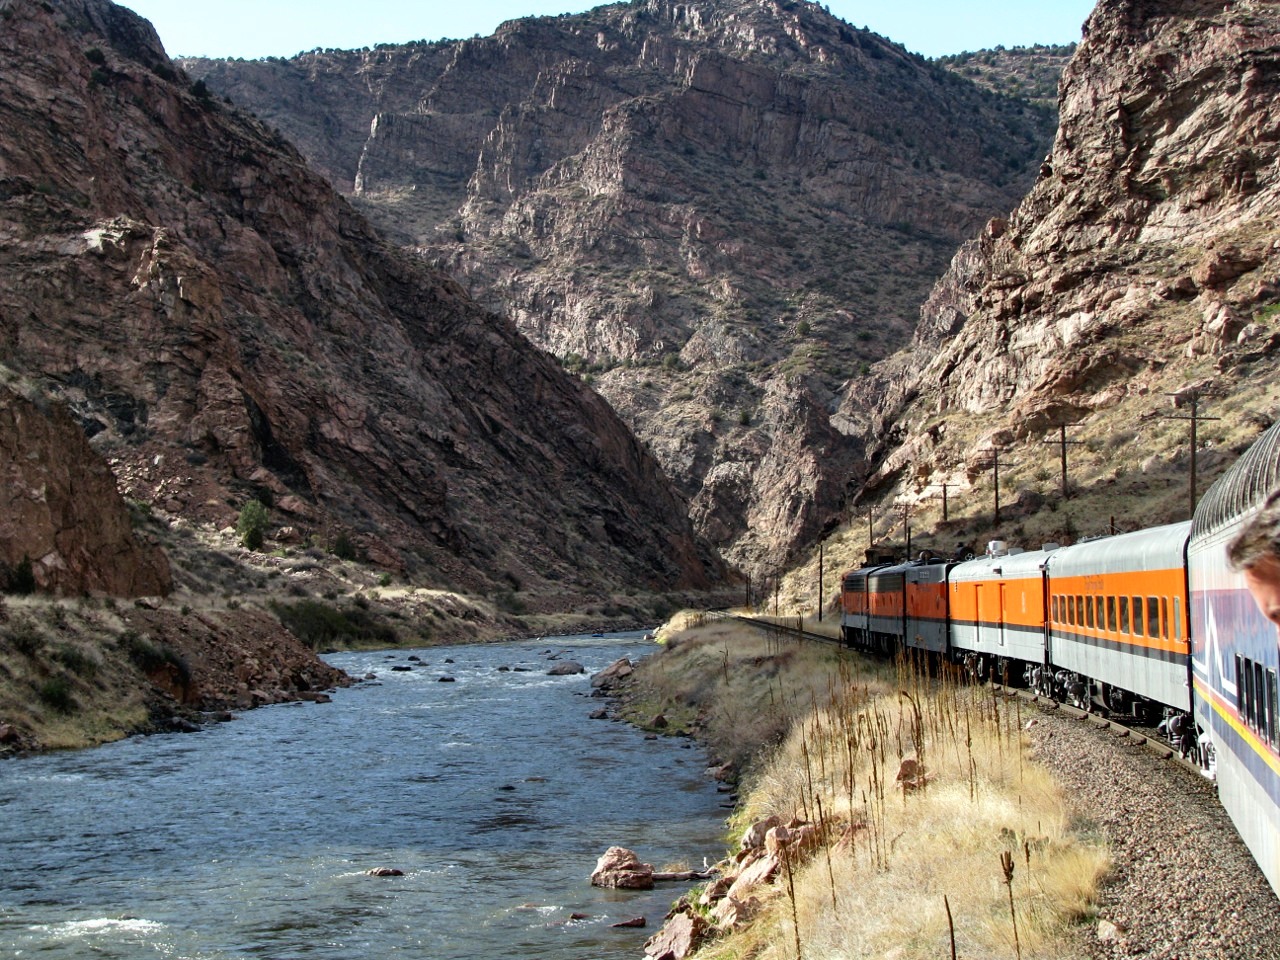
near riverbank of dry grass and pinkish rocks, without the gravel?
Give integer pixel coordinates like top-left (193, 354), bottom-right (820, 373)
top-left (620, 616), bottom-right (1110, 960)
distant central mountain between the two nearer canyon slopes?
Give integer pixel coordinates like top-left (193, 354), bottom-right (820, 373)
top-left (184, 0), bottom-right (1052, 571)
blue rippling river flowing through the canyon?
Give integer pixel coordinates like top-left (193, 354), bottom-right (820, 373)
top-left (0, 634), bottom-right (726, 960)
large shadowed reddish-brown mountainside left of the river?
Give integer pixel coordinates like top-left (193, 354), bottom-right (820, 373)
top-left (0, 0), bottom-right (722, 603)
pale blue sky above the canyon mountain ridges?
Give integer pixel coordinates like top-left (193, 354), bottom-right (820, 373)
top-left (123, 0), bottom-right (1093, 59)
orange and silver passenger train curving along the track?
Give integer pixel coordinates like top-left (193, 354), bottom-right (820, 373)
top-left (840, 421), bottom-right (1280, 895)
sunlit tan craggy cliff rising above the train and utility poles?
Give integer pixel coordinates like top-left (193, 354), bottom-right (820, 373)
top-left (841, 0), bottom-right (1280, 506)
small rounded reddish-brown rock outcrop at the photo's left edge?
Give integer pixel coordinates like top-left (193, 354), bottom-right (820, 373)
top-left (0, 369), bottom-right (172, 596)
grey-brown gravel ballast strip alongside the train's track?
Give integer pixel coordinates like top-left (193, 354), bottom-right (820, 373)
top-left (1030, 710), bottom-right (1280, 960)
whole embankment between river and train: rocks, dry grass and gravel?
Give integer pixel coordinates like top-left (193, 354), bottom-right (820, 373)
top-left (611, 616), bottom-right (1280, 960)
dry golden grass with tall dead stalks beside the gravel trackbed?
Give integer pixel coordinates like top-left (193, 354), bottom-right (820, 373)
top-left (646, 623), bottom-right (1108, 960)
